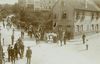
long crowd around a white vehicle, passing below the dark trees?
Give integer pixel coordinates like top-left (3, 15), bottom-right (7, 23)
top-left (12, 15), bottom-right (87, 46)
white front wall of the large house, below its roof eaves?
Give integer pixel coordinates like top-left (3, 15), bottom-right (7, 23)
top-left (75, 16), bottom-right (100, 32)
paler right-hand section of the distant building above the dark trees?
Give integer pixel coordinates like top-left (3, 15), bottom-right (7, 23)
top-left (34, 0), bottom-right (57, 10)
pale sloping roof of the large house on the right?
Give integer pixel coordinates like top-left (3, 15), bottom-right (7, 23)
top-left (59, 0), bottom-right (100, 11)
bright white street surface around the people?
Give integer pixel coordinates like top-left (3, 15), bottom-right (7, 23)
top-left (0, 23), bottom-right (100, 64)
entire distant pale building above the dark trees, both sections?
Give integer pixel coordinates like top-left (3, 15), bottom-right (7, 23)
top-left (18, 0), bottom-right (57, 10)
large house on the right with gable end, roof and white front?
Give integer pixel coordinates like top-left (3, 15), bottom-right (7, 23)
top-left (53, 0), bottom-right (100, 38)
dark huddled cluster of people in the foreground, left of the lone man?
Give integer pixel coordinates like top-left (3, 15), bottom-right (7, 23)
top-left (7, 38), bottom-right (24, 63)
